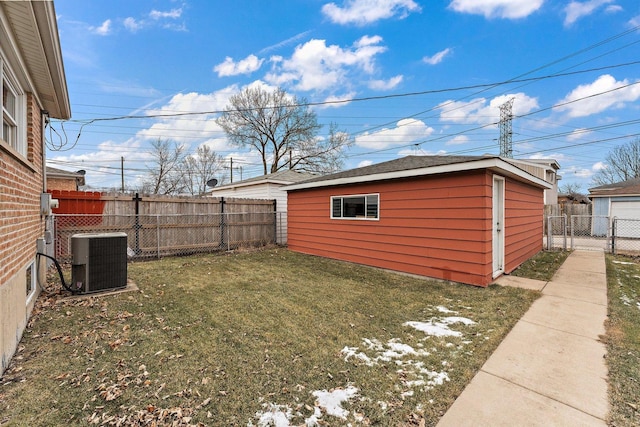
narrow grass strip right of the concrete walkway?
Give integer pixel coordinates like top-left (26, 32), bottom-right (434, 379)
top-left (606, 256), bottom-right (640, 426)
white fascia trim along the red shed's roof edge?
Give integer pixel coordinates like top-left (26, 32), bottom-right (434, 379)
top-left (284, 157), bottom-right (553, 191)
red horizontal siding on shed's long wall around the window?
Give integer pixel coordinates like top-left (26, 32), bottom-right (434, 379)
top-left (288, 171), bottom-right (492, 286)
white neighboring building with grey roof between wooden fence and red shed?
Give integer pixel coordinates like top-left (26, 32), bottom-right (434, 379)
top-left (207, 170), bottom-right (317, 244)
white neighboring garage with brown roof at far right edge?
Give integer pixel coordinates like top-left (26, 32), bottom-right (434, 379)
top-left (589, 178), bottom-right (640, 238)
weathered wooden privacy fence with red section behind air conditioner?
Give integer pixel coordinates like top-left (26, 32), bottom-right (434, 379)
top-left (53, 194), bottom-right (281, 260)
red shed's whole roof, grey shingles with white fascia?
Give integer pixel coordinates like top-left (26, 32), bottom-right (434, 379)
top-left (285, 156), bottom-right (551, 191)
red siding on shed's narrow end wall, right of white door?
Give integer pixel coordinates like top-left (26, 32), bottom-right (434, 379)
top-left (505, 179), bottom-right (544, 273)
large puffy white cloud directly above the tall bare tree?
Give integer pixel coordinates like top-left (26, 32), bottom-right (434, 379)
top-left (265, 36), bottom-right (387, 91)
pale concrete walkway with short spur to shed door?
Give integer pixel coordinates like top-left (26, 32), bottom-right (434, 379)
top-left (438, 251), bottom-right (609, 427)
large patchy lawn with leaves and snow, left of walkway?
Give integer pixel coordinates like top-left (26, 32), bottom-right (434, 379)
top-left (0, 249), bottom-right (544, 426)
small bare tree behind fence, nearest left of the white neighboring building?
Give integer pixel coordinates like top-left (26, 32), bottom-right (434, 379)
top-left (181, 145), bottom-right (225, 196)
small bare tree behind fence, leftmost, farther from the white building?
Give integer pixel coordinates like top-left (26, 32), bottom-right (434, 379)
top-left (143, 138), bottom-right (186, 194)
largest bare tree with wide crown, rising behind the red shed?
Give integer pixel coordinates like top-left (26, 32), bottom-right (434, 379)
top-left (218, 87), bottom-right (349, 175)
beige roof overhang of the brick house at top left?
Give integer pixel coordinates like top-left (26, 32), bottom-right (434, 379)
top-left (0, 0), bottom-right (71, 119)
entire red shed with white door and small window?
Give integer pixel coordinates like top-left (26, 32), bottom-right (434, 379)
top-left (286, 156), bottom-right (551, 286)
